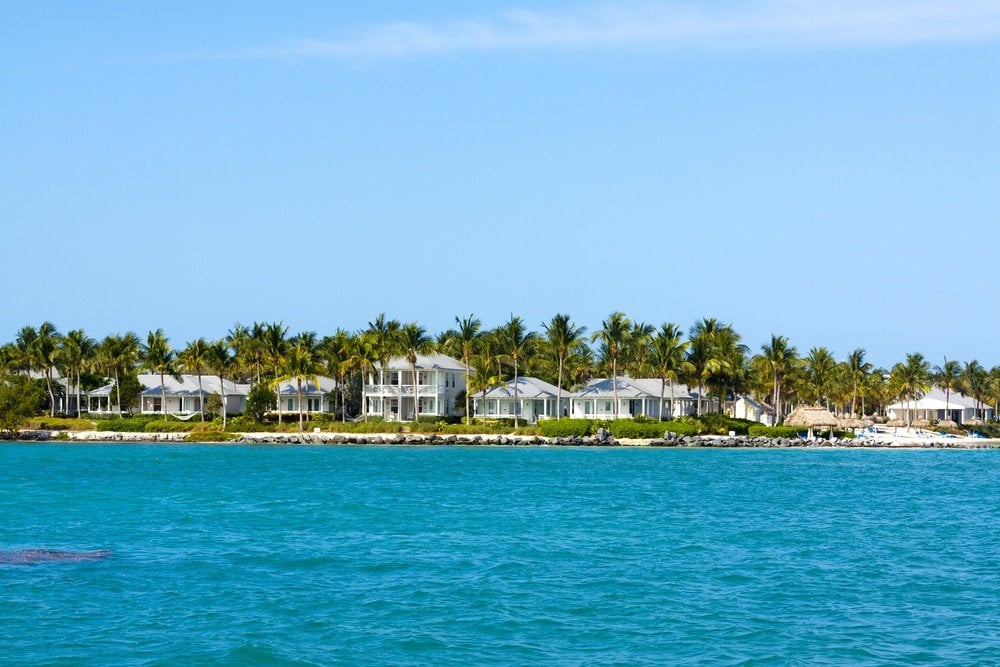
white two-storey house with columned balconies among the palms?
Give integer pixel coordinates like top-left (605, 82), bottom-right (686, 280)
top-left (363, 353), bottom-right (465, 421)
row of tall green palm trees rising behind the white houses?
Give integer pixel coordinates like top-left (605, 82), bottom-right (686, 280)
top-left (0, 312), bottom-right (1000, 428)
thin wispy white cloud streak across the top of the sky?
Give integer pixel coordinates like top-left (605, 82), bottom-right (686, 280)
top-left (254, 0), bottom-right (1000, 59)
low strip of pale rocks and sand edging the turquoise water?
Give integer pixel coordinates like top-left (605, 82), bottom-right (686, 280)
top-left (5, 431), bottom-right (1000, 449)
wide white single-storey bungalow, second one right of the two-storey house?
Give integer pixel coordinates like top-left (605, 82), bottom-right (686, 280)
top-left (570, 377), bottom-right (717, 419)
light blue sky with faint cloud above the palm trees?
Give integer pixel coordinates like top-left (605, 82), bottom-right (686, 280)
top-left (0, 0), bottom-right (1000, 366)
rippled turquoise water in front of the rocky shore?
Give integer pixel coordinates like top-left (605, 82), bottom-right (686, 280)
top-left (0, 444), bottom-right (1000, 665)
